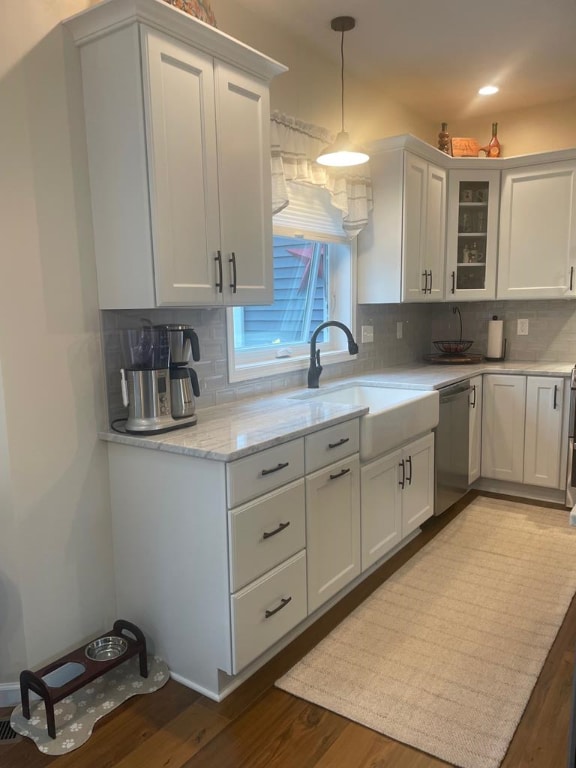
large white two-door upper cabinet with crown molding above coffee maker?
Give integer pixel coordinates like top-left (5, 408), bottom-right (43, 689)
top-left (67, 0), bottom-right (285, 309)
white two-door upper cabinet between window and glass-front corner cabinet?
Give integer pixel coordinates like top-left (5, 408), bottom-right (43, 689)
top-left (358, 137), bottom-right (447, 304)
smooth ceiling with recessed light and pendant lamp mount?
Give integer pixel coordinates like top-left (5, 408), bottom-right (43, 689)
top-left (230, 0), bottom-right (576, 121)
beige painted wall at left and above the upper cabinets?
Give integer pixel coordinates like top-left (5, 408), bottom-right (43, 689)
top-left (0, 0), bottom-right (576, 688)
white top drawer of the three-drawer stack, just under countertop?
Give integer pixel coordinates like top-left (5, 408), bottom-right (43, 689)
top-left (226, 438), bottom-right (304, 509)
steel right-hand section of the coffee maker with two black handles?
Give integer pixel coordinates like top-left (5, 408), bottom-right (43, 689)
top-left (155, 325), bottom-right (200, 423)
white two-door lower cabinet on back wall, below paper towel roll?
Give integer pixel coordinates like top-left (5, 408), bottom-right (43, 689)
top-left (482, 374), bottom-right (563, 488)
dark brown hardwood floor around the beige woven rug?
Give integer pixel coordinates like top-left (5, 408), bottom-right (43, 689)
top-left (0, 494), bottom-right (576, 768)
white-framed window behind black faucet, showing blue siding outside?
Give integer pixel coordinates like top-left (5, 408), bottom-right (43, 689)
top-left (228, 188), bottom-right (356, 381)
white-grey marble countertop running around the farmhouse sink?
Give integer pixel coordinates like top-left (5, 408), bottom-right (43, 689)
top-left (99, 361), bottom-right (574, 461)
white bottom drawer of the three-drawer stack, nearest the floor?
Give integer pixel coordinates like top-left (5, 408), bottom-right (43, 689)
top-left (231, 551), bottom-right (307, 674)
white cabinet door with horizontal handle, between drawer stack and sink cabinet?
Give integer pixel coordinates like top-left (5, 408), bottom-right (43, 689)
top-left (306, 454), bottom-right (360, 613)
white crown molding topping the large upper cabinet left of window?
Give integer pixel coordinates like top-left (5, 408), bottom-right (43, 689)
top-left (64, 0), bottom-right (288, 80)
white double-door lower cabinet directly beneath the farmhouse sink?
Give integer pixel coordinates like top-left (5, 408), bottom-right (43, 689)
top-left (361, 433), bottom-right (434, 571)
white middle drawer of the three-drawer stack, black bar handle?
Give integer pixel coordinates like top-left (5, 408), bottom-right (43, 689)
top-left (229, 479), bottom-right (306, 592)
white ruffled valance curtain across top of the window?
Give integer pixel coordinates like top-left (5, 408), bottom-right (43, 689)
top-left (270, 112), bottom-right (372, 238)
